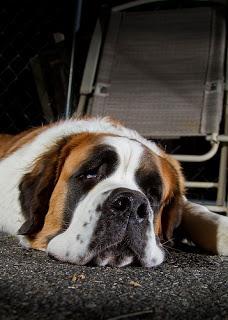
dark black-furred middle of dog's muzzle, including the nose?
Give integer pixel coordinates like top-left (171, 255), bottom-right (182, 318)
top-left (90, 188), bottom-right (164, 266)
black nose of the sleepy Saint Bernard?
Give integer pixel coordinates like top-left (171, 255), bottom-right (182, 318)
top-left (108, 188), bottom-right (149, 222)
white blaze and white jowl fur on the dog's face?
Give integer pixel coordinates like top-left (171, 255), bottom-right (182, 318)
top-left (47, 137), bottom-right (164, 267)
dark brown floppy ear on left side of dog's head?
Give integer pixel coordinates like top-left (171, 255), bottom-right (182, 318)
top-left (18, 141), bottom-right (67, 236)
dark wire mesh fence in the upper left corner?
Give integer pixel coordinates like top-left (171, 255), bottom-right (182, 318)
top-left (0, 1), bottom-right (67, 133)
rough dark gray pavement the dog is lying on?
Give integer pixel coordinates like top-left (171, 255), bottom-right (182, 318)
top-left (0, 234), bottom-right (228, 320)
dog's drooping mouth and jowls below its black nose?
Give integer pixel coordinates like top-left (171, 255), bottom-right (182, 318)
top-left (47, 196), bottom-right (164, 268)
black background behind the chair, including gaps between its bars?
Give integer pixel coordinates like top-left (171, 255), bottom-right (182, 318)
top-left (0, 0), bottom-right (225, 200)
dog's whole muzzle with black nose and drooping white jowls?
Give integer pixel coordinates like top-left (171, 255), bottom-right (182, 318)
top-left (47, 188), bottom-right (164, 267)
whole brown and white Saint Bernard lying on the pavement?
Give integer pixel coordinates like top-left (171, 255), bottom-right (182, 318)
top-left (0, 118), bottom-right (228, 267)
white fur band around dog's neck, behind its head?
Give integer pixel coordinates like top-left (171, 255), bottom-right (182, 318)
top-left (0, 118), bottom-right (160, 235)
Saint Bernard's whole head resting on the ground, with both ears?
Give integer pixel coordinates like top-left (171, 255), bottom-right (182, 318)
top-left (19, 133), bottom-right (183, 267)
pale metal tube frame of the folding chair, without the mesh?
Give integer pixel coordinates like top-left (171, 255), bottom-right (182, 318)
top-left (75, 0), bottom-right (228, 215)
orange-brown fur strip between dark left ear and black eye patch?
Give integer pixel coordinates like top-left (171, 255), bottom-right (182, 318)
top-left (27, 133), bottom-right (107, 249)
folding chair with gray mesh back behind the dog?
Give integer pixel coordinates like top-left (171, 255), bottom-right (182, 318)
top-left (77, 1), bottom-right (228, 212)
